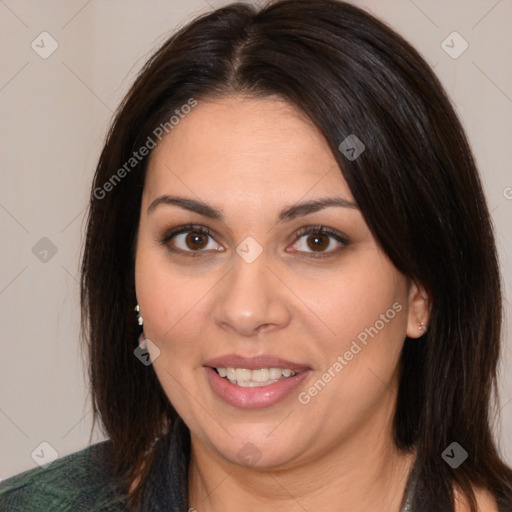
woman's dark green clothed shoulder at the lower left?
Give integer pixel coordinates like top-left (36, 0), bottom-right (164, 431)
top-left (0, 441), bottom-right (125, 512)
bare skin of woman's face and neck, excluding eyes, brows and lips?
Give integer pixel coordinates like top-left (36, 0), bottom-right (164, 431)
top-left (135, 96), bottom-right (436, 512)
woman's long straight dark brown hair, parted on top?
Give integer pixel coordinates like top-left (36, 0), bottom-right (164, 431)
top-left (81, 0), bottom-right (512, 512)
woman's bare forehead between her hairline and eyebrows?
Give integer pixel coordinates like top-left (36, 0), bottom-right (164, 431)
top-left (144, 97), bottom-right (352, 206)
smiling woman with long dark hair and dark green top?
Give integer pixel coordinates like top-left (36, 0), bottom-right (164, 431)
top-left (0, 0), bottom-right (512, 512)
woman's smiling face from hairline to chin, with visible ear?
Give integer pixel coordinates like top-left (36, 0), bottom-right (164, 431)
top-left (136, 97), bottom-right (425, 468)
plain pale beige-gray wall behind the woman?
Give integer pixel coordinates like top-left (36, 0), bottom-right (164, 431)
top-left (0, 0), bottom-right (512, 478)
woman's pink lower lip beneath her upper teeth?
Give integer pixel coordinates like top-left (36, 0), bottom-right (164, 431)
top-left (205, 367), bottom-right (311, 409)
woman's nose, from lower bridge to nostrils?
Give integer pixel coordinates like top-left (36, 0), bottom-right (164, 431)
top-left (213, 253), bottom-right (292, 337)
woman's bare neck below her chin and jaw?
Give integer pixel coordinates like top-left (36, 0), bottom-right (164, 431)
top-left (189, 402), bottom-right (414, 512)
